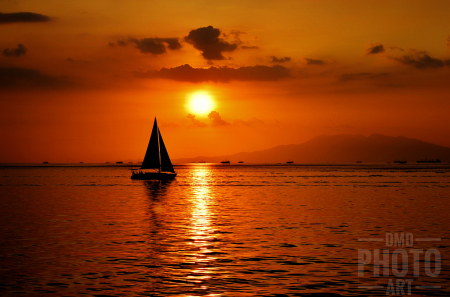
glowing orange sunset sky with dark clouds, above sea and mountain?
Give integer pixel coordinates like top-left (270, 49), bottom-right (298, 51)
top-left (0, 0), bottom-right (450, 162)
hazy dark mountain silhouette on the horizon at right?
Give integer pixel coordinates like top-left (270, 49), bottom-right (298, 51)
top-left (173, 134), bottom-right (450, 164)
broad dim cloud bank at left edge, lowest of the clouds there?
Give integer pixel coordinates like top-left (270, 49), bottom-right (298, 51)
top-left (0, 67), bottom-right (72, 89)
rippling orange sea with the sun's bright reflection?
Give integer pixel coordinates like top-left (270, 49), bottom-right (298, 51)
top-left (0, 164), bottom-right (450, 296)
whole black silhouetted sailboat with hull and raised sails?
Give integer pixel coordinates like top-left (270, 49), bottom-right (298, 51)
top-left (131, 118), bottom-right (177, 180)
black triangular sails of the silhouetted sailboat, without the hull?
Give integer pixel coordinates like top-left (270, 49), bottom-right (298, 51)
top-left (141, 118), bottom-right (175, 172)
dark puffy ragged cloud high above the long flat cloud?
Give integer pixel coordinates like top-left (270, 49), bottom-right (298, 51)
top-left (184, 26), bottom-right (238, 60)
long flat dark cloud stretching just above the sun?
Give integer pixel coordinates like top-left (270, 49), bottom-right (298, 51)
top-left (135, 64), bottom-right (292, 83)
